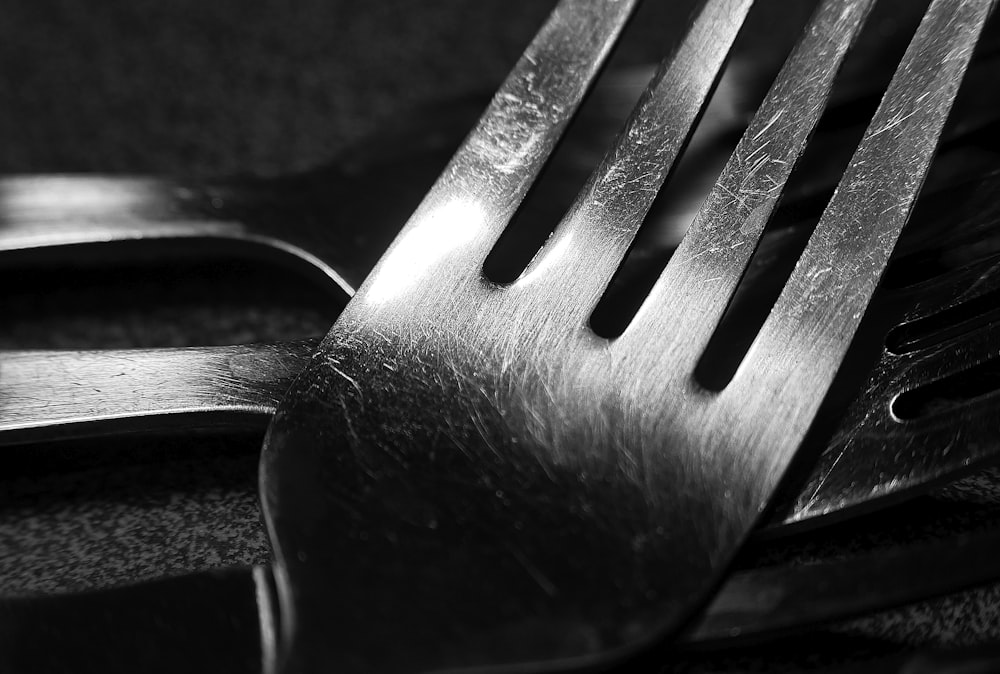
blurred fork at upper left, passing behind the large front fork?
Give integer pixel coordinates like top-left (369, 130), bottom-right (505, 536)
top-left (0, 47), bottom-right (1000, 300)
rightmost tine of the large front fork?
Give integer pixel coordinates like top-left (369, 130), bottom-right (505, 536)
top-left (722, 0), bottom-right (995, 448)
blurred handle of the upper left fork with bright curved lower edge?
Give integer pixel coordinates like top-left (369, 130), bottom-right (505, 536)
top-left (0, 176), bottom-right (362, 297)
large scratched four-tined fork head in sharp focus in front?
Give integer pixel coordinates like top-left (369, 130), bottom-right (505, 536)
top-left (261, 0), bottom-right (991, 671)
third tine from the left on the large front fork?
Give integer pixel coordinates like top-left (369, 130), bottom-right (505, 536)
top-left (630, 0), bottom-right (874, 362)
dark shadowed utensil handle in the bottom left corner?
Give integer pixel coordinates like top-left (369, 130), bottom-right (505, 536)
top-left (0, 567), bottom-right (275, 674)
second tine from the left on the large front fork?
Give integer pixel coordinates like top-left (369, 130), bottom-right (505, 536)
top-left (518, 0), bottom-right (753, 308)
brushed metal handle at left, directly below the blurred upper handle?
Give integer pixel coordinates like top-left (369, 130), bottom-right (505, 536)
top-left (0, 340), bottom-right (317, 445)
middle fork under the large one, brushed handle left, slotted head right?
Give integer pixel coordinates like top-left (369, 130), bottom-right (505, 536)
top-left (0, 173), bottom-right (1000, 535)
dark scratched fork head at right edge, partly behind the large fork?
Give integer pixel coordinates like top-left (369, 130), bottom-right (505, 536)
top-left (770, 173), bottom-right (1000, 529)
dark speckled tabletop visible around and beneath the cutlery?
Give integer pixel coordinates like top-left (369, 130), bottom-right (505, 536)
top-left (0, 0), bottom-right (1000, 671)
